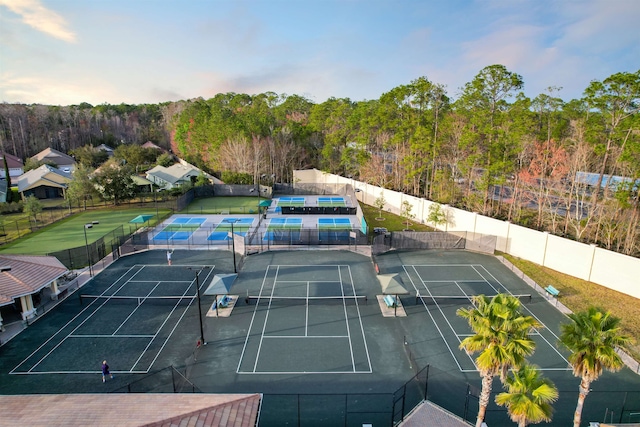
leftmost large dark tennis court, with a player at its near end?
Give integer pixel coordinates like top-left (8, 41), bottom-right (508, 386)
top-left (10, 265), bottom-right (213, 375)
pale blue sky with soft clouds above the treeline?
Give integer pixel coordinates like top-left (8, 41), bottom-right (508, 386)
top-left (0, 0), bottom-right (640, 105)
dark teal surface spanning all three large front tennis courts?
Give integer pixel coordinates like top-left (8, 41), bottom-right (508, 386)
top-left (0, 250), bottom-right (640, 426)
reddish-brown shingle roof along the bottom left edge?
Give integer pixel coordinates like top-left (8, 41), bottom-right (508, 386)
top-left (0, 394), bottom-right (261, 427)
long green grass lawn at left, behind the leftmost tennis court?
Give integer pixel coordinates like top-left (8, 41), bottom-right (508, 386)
top-left (0, 207), bottom-right (170, 255)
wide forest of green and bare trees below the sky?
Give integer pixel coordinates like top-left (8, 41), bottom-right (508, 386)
top-left (0, 65), bottom-right (640, 256)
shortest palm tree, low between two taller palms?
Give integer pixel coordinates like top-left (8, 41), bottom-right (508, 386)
top-left (496, 365), bottom-right (558, 427)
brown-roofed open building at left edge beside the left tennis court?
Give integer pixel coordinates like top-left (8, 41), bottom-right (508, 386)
top-left (0, 255), bottom-right (69, 330)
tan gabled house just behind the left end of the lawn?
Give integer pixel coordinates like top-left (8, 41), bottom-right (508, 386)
top-left (18, 165), bottom-right (71, 200)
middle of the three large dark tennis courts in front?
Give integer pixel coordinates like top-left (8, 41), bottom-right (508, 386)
top-left (236, 265), bottom-right (371, 374)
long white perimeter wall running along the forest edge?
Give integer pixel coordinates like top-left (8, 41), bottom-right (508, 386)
top-left (293, 169), bottom-right (640, 298)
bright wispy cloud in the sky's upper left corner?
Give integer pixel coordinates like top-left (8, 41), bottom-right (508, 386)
top-left (0, 0), bottom-right (76, 43)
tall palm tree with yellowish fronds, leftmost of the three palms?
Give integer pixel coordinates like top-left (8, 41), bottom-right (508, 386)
top-left (457, 294), bottom-right (542, 427)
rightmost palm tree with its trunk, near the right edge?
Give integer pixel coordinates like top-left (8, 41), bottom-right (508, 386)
top-left (560, 307), bottom-right (631, 427)
